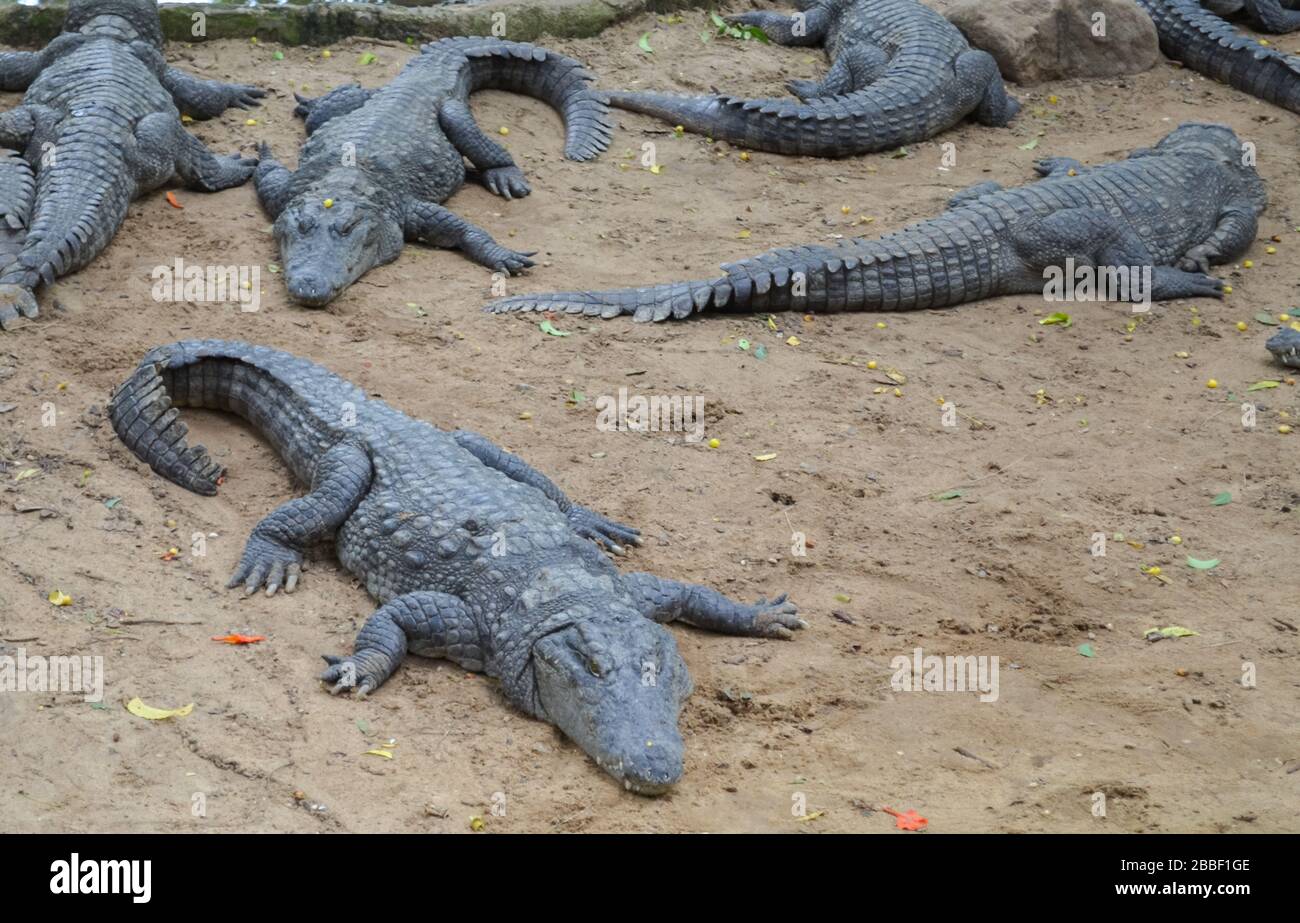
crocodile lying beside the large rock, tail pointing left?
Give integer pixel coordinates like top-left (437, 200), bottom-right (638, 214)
top-left (607, 0), bottom-right (1021, 157)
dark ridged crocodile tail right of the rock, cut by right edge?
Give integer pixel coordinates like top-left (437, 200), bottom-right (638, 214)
top-left (1138, 0), bottom-right (1300, 113)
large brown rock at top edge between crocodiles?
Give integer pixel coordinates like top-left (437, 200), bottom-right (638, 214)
top-left (932, 0), bottom-right (1160, 83)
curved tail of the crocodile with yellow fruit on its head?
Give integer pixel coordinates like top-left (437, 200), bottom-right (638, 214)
top-left (421, 36), bottom-right (614, 160)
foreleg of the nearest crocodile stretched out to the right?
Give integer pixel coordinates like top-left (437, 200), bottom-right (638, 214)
top-left (621, 573), bottom-right (807, 638)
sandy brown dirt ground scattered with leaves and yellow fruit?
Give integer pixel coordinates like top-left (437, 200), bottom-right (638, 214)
top-left (0, 1), bottom-right (1300, 833)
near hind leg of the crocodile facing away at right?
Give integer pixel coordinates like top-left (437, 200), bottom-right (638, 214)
top-left (1013, 208), bottom-right (1223, 302)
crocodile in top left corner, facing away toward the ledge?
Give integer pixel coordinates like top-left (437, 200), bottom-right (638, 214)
top-left (0, 0), bottom-right (264, 328)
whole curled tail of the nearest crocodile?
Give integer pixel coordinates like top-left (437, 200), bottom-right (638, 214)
top-left (108, 339), bottom-right (365, 497)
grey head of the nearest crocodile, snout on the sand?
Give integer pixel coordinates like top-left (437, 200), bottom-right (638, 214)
top-left (533, 612), bottom-right (690, 794)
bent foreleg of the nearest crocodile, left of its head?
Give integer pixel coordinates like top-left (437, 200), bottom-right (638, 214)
top-left (320, 590), bottom-right (485, 698)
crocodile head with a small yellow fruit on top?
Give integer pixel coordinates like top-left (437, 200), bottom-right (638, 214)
top-left (276, 183), bottom-right (403, 307)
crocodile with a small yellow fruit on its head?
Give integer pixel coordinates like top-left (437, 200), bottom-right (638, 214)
top-left (254, 36), bottom-right (611, 307)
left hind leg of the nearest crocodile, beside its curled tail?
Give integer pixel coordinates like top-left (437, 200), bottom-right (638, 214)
top-left (226, 442), bottom-right (372, 595)
